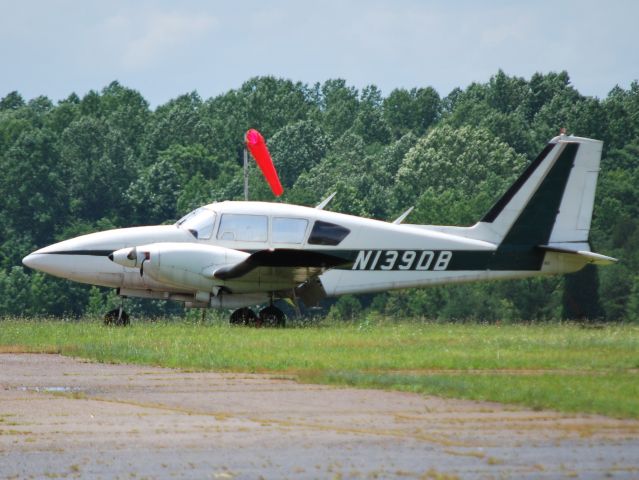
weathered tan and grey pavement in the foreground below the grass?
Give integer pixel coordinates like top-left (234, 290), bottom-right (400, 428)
top-left (0, 353), bottom-right (639, 478)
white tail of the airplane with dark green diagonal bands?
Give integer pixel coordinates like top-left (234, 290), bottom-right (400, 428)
top-left (448, 135), bottom-right (616, 271)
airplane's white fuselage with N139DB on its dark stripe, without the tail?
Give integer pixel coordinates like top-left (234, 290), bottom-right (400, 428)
top-left (24, 202), bottom-right (584, 308)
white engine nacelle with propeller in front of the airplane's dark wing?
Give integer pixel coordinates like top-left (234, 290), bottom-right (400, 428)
top-left (112, 243), bottom-right (249, 293)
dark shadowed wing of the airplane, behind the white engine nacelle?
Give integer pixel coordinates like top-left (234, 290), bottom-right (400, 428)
top-left (212, 249), bottom-right (352, 291)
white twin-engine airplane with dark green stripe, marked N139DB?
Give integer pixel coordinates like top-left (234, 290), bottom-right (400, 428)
top-left (23, 135), bottom-right (616, 325)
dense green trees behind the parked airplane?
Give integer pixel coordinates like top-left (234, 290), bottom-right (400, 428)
top-left (0, 71), bottom-right (639, 321)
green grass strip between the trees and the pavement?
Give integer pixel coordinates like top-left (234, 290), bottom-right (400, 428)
top-left (0, 319), bottom-right (639, 418)
